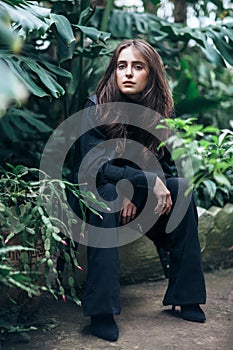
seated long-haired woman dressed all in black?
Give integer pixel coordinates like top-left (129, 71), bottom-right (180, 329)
top-left (75, 39), bottom-right (206, 341)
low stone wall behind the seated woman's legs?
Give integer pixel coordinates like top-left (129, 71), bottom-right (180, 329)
top-left (74, 204), bottom-right (233, 284)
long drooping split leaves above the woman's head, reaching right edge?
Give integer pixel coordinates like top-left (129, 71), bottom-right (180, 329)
top-left (91, 8), bottom-right (233, 67)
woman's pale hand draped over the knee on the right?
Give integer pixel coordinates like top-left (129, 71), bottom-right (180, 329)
top-left (153, 176), bottom-right (172, 215)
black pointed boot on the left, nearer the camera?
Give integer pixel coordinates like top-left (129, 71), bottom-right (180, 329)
top-left (91, 314), bottom-right (119, 341)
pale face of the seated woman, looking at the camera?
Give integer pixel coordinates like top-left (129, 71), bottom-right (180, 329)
top-left (116, 46), bottom-right (149, 100)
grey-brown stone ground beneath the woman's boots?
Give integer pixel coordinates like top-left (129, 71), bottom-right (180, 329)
top-left (2, 269), bottom-right (233, 350)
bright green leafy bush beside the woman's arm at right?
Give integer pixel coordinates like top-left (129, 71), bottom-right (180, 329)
top-left (159, 118), bottom-right (233, 208)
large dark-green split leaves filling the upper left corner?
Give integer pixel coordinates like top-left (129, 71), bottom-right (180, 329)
top-left (0, 0), bottom-right (75, 164)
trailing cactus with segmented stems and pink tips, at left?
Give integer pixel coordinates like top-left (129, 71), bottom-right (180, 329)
top-left (0, 165), bottom-right (106, 304)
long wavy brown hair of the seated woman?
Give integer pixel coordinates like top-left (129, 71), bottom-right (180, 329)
top-left (96, 39), bottom-right (174, 154)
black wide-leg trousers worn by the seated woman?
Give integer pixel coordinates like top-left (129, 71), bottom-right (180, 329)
top-left (83, 178), bottom-right (206, 316)
